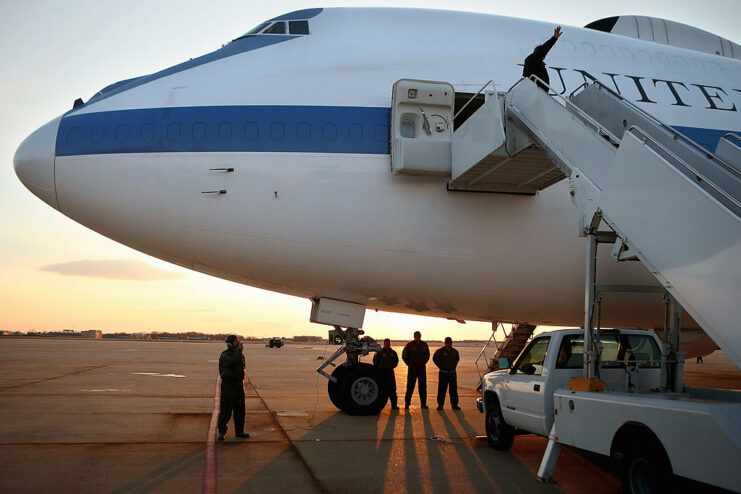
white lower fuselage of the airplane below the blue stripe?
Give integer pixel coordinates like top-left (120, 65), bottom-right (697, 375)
top-left (57, 153), bottom-right (663, 326)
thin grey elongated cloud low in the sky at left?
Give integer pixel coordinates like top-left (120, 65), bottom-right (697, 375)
top-left (40, 259), bottom-right (188, 281)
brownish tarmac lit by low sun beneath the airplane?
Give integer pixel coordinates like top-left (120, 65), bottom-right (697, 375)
top-left (0, 338), bottom-right (741, 494)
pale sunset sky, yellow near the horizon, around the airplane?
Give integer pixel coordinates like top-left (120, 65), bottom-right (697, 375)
top-left (0, 0), bottom-right (741, 339)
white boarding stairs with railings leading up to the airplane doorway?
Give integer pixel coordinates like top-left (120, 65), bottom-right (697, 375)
top-left (460, 79), bottom-right (741, 367)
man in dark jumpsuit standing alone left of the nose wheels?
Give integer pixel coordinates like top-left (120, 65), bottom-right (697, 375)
top-left (218, 335), bottom-right (250, 441)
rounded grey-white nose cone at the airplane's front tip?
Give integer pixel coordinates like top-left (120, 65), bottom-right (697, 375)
top-left (13, 117), bottom-right (62, 209)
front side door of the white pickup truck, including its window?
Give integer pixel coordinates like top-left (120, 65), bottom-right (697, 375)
top-left (501, 336), bottom-right (551, 435)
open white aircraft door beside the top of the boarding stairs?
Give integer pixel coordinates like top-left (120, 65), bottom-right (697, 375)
top-left (391, 79), bottom-right (455, 177)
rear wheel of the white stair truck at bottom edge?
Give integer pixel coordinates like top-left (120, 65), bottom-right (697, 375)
top-left (620, 443), bottom-right (671, 494)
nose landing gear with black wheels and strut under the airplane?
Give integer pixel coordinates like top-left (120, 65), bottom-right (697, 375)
top-left (316, 326), bottom-right (388, 415)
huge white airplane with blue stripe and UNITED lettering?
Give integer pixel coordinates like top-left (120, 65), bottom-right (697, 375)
top-left (14, 8), bottom-right (741, 411)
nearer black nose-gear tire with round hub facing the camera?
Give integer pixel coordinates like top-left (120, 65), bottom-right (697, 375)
top-left (339, 363), bottom-right (388, 415)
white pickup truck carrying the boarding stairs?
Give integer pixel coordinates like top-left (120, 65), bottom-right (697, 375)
top-left (477, 330), bottom-right (741, 492)
